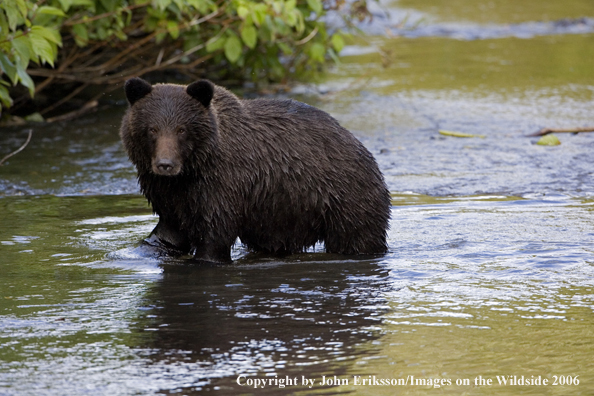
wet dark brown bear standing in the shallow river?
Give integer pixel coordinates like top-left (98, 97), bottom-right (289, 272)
top-left (120, 78), bottom-right (391, 262)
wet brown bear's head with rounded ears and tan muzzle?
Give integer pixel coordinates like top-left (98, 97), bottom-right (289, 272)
top-left (120, 78), bottom-right (217, 176)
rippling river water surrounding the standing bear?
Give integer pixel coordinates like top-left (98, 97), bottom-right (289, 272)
top-left (0, 0), bottom-right (594, 395)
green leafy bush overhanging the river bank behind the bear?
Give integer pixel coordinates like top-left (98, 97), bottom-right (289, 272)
top-left (0, 0), bottom-right (366, 114)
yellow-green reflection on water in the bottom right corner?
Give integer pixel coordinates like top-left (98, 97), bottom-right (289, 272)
top-left (300, 284), bottom-right (594, 395)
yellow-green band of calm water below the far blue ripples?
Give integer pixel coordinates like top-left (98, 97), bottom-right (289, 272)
top-left (330, 35), bottom-right (594, 101)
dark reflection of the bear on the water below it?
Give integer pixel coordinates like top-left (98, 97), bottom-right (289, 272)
top-left (136, 253), bottom-right (389, 394)
